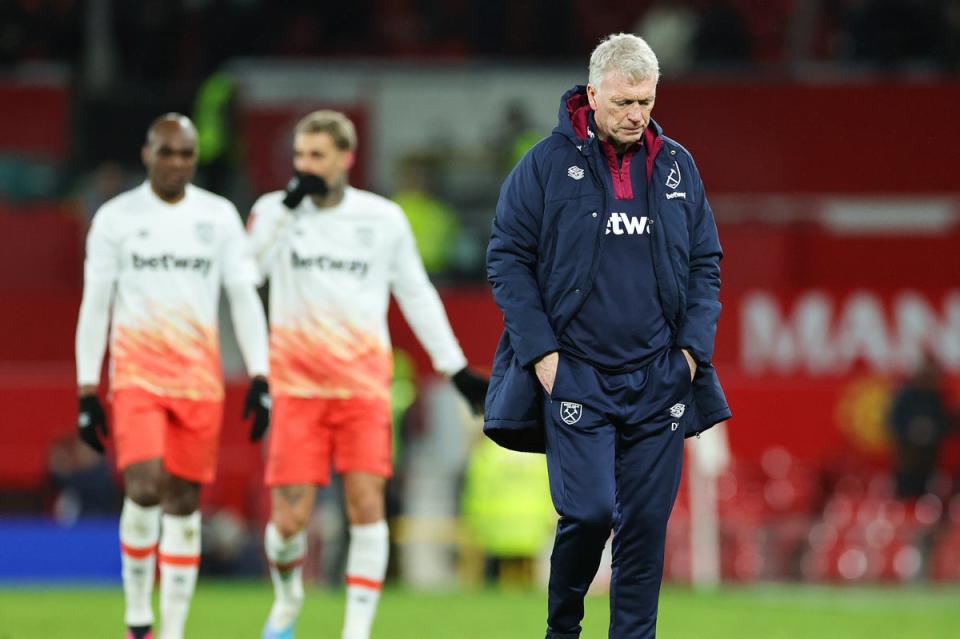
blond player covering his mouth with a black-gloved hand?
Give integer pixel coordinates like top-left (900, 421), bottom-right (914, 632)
top-left (248, 111), bottom-right (486, 639)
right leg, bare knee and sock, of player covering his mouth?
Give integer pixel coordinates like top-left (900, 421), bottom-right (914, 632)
top-left (343, 472), bottom-right (390, 639)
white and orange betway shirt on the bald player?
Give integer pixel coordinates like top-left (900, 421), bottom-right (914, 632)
top-left (77, 182), bottom-right (266, 399)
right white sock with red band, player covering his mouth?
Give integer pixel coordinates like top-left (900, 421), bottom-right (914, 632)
top-left (343, 520), bottom-right (390, 639)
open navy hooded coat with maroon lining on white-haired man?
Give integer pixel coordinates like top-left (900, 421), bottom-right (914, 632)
top-left (484, 86), bottom-right (731, 452)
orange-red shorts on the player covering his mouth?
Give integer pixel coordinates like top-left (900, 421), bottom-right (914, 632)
top-left (265, 396), bottom-right (393, 486)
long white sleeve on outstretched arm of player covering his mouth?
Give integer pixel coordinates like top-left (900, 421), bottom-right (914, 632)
top-left (391, 212), bottom-right (467, 375)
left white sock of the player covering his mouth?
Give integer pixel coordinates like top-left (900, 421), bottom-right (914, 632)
top-left (263, 522), bottom-right (307, 630)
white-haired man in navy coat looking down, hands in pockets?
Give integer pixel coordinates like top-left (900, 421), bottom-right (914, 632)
top-left (484, 33), bottom-right (730, 639)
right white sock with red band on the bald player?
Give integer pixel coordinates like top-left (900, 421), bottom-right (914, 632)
top-left (160, 511), bottom-right (200, 639)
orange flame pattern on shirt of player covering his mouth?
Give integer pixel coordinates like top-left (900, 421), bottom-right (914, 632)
top-left (270, 315), bottom-right (393, 400)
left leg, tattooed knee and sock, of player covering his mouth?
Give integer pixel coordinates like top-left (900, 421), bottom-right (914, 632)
top-left (263, 484), bottom-right (317, 639)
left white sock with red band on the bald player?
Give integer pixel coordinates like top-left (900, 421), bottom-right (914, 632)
top-left (120, 497), bottom-right (160, 626)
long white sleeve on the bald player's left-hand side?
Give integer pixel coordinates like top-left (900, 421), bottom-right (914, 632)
top-left (74, 215), bottom-right (120, 386)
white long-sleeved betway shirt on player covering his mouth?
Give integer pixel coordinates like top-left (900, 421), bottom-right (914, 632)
top-left (247, 187), bottom-right (467, 399)
